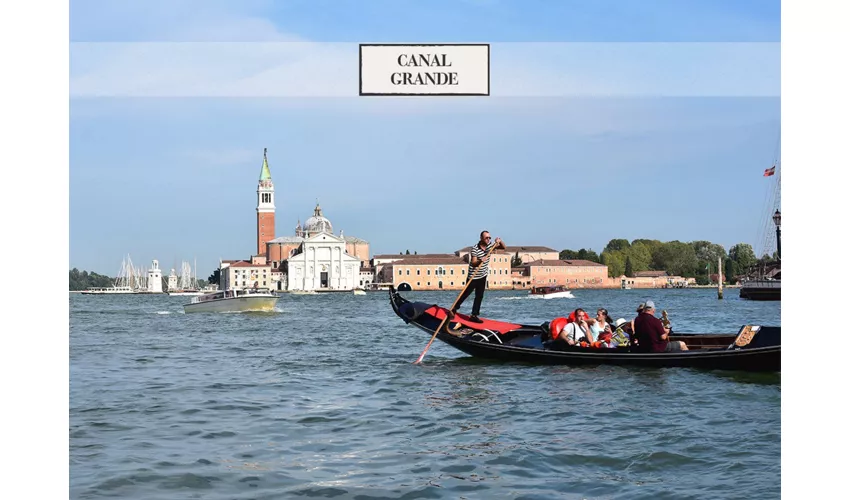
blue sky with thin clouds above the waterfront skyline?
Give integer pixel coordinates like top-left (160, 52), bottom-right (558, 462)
top-left (70, 0), bottom-right (780, 277)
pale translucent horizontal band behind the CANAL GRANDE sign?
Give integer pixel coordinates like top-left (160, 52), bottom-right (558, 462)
top-left (70, 41), bottom-right (780, 101)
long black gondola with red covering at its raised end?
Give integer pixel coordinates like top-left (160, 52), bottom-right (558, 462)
top-left (389, 287), bottom-right (782, 372)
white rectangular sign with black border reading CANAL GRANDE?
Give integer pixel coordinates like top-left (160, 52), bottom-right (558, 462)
top-left (360, 43), bottom-right (490, 96)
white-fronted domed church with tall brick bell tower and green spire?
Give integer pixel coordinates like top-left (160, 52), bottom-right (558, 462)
top-left (240, 149), bottom-right (373, 291)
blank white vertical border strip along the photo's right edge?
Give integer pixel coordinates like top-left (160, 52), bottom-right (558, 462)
top-left (784, 0), bottom-right (850, 498)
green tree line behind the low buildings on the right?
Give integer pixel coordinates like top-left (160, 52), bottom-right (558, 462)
top-left (558, 239), bottom-right (776, 284)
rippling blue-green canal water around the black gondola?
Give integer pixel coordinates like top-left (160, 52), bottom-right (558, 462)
top-left (69, 289), bottom-right (781, 500)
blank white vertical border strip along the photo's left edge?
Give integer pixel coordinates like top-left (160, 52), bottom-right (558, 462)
top-left (0, 1), bottom-right (69, 498)
